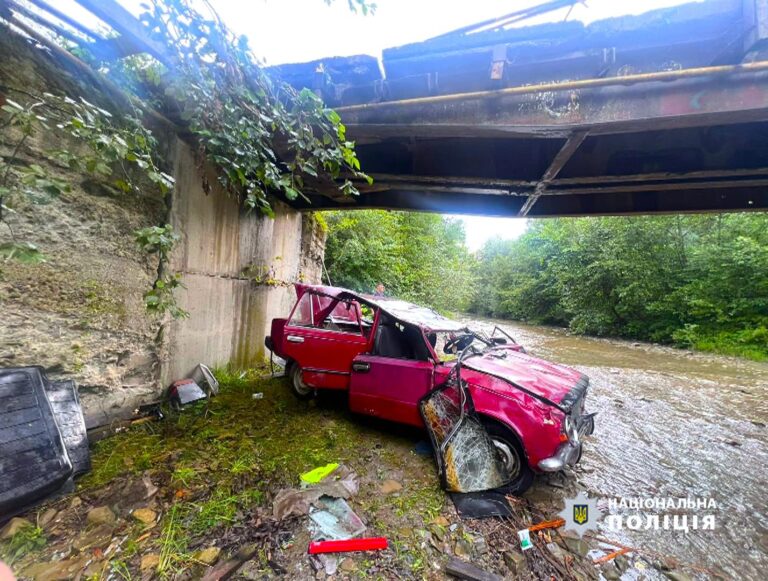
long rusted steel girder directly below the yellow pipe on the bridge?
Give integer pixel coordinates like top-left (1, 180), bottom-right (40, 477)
top-left (342, 71), bottom-right (768, 142)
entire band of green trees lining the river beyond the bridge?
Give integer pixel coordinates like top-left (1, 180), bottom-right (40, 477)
top-left (326, 211), bottom-right (768, 359)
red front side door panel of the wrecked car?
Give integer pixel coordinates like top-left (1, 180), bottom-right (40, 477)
top-left (349, 354), bottom-right (435, 427)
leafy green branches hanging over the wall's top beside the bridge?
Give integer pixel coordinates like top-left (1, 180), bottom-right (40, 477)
top-left (141, 0), bottom-right (370, 215)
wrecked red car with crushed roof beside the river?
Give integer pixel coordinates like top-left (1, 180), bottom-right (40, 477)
top-left (266, 284), bottom-right (594, 494)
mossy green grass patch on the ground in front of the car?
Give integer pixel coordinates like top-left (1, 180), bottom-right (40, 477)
top-left (78, 369), bottom-right (445, 577)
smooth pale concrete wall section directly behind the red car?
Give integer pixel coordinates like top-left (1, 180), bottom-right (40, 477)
top-left (162, 135), bottom-right (325, 384)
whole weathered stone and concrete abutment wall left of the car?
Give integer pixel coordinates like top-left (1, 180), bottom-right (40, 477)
top-left (0, 34), bottom-right (325, 427)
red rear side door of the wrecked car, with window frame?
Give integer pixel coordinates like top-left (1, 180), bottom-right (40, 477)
top-left (283, 291), bottom-right (369, 389)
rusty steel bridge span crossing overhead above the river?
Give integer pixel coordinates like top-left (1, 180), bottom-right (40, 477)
top-left (280, 0), bottom-right (768, 217)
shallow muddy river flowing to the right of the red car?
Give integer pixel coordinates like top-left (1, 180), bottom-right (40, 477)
top-left (468, 320), bottom-right (768, 579)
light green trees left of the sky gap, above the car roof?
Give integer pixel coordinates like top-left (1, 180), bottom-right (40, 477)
top-left (324, 210), bottom-right (474, 311)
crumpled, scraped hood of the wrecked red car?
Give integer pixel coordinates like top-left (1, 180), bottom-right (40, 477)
top-left (462, 349), bottom-right (589, 410)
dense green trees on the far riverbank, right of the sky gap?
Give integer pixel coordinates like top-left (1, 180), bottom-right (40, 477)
top-left (470, 214), bottom-right (768, 359)
